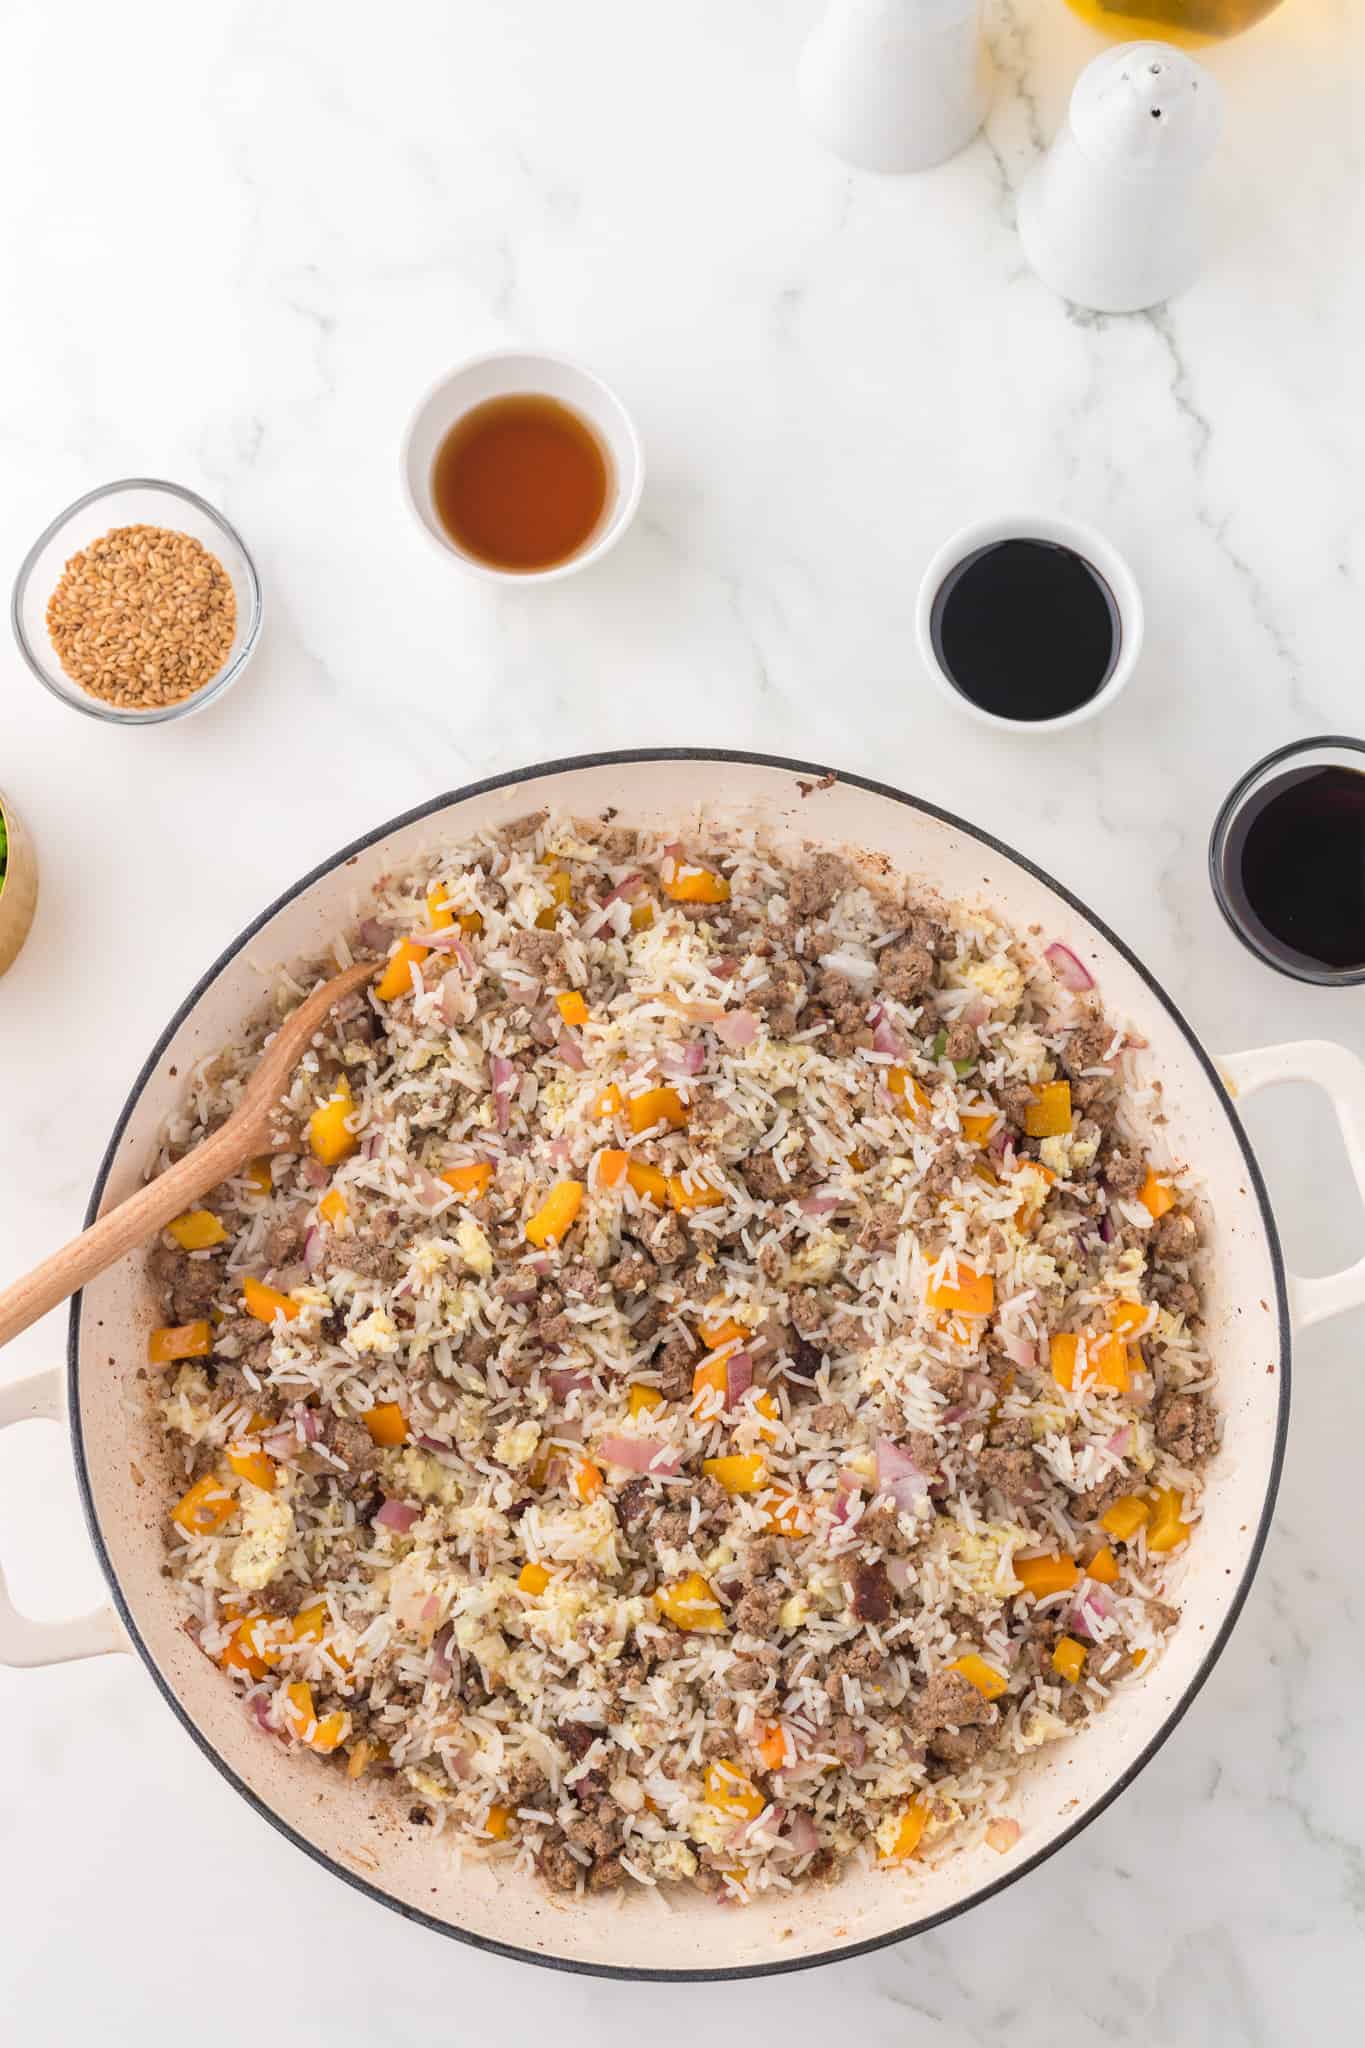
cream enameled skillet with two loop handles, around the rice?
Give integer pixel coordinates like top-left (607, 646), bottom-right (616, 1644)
top-left (0, 750), bottom-right (1365, 1978)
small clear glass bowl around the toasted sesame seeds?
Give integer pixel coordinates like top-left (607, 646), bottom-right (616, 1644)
top-left (10, 477), bottom-right (260, 725)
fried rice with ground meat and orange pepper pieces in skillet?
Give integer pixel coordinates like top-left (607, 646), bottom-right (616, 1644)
top-left (147, 817), bottom-right (1218, 1901)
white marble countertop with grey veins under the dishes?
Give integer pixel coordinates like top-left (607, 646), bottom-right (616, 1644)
top-left (0, 0), bottom-right (1365, 2048)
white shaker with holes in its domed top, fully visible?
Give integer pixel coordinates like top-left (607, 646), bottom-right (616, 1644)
top-left (1019, 43), bottom-right (1222, 313)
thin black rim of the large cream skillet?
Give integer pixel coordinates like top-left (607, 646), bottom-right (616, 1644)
top-left (68, 748), bottom-right (1289, 1982)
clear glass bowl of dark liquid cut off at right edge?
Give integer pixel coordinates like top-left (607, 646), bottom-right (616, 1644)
top-left (1209, 735), bottom-right (1365, 989)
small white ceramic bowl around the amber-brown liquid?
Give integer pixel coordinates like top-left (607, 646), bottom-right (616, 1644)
top-left (403, 348), bottom-right (645, 584)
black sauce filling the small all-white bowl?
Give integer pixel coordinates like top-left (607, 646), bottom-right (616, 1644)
top-left (929, 541), bottom-right (1121, 725)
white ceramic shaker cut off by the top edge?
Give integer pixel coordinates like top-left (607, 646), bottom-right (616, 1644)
top-left (796, 0), bottom-right (990, 170)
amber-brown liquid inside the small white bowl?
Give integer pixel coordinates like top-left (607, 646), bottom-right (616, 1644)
top-left (432, 391), bottom-right (612, 575)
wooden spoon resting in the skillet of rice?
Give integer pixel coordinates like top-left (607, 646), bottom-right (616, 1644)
top-left (0, 961), bottom-right (379, 1343)
